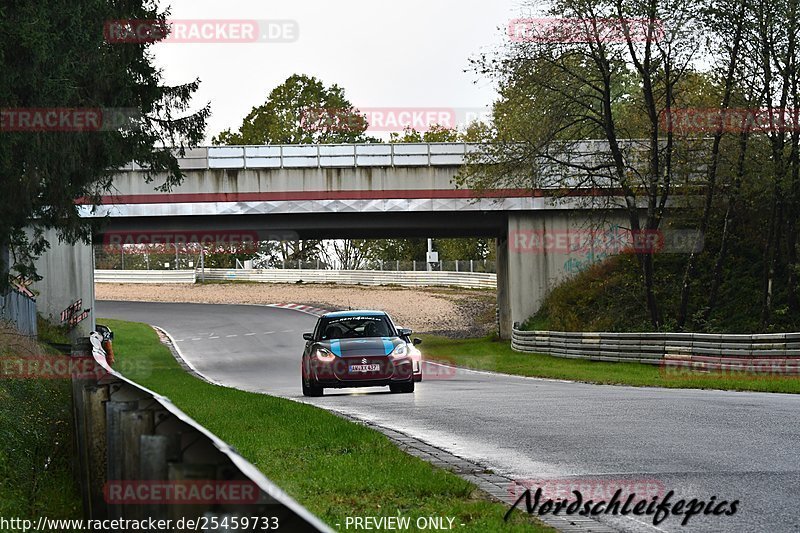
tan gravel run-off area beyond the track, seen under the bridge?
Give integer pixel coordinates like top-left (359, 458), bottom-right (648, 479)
top-left (95, 282), bottom-right (496, 338)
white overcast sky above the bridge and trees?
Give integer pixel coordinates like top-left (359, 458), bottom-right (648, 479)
top-left (152, 0), bottom-right (536, 141)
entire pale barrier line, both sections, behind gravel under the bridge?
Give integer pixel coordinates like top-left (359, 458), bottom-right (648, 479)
top-left (94, 268), bottom-right (497, 289)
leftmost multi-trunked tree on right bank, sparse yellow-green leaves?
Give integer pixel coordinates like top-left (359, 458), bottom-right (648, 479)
top-left (459, 0), bottom-right (699, 329)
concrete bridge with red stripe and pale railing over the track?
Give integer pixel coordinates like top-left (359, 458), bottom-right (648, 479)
top-left (73, 143), bottom-right (623, 337)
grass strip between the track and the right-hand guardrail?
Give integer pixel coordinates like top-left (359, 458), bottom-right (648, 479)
top-left (421, 335), bottom-right (800, 394)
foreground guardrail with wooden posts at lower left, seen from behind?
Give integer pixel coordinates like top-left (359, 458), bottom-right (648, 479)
top-left (72, 333), bottom-right (332, 532)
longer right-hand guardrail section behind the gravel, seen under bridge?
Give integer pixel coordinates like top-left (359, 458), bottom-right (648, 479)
top-left (203, 269), bottom-right (497, 289)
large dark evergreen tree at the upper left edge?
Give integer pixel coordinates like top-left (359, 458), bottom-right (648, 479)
top-left (0, 0), bottom-right (209, 286)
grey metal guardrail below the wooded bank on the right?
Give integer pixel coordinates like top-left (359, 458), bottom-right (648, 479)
top-left (511, 328), bottom-right (800, 368)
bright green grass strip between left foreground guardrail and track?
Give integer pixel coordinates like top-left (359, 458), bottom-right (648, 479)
top-left (102, 319), bottom-right (552, 532)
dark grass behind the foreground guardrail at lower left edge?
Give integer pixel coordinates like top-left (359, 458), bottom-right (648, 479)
top-left (0, 324), bottom-right (82, 523)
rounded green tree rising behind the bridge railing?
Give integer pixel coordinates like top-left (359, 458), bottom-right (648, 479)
top-left (211, 74), bottom-right (380, 145)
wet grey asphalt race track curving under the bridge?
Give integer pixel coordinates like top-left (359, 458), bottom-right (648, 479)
top-left (96, 301), bottom-right (800, 532)
